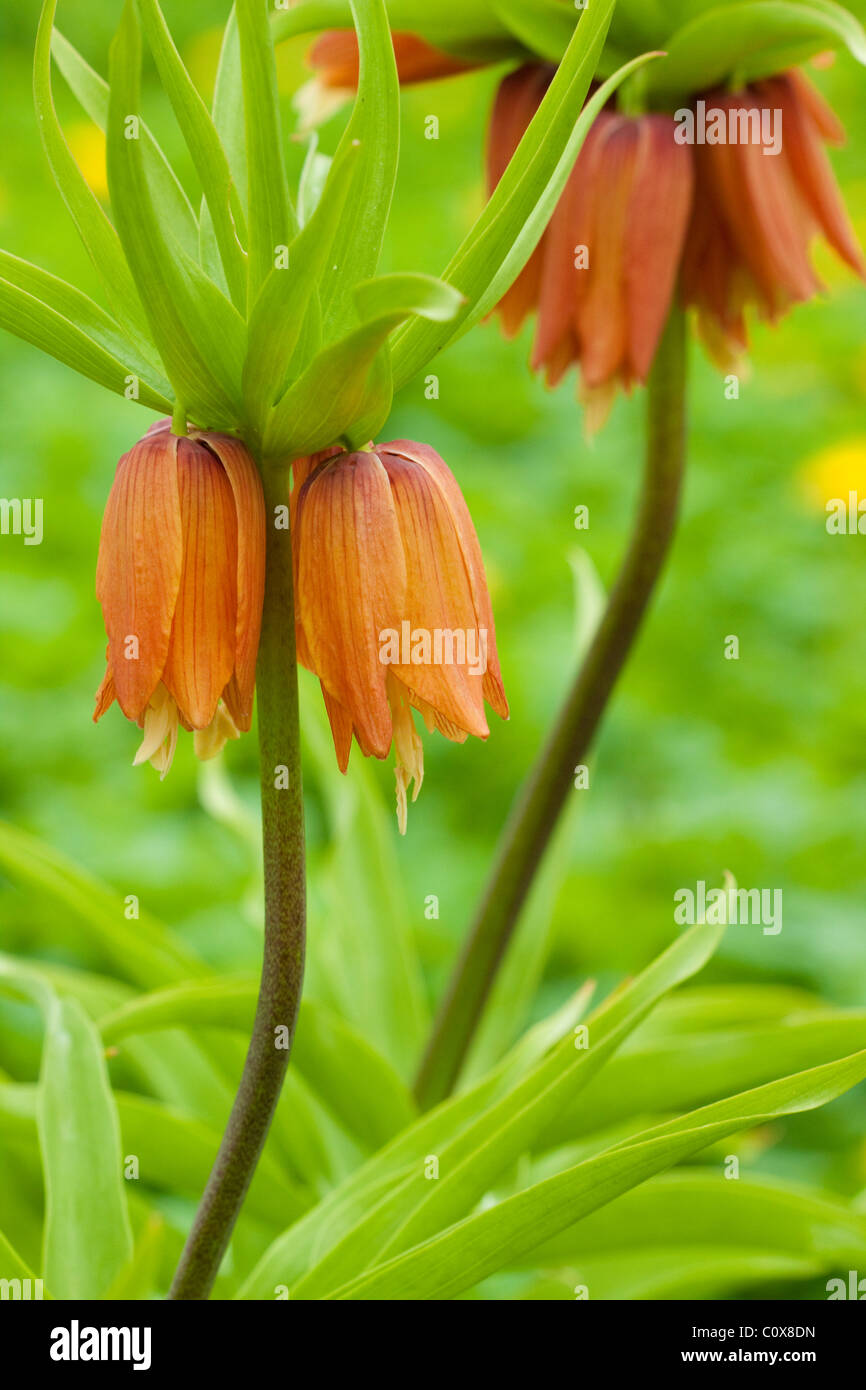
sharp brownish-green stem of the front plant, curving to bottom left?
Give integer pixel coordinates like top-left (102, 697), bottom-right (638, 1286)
top-left (168, 467), bottom-right (306, 1300)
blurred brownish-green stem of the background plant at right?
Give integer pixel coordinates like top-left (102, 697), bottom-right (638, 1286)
top-left (416, 309), bottom-right (687, 1106)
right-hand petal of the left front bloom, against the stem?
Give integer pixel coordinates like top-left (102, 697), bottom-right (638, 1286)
top-left (195, 434), bottom-right (267, 730)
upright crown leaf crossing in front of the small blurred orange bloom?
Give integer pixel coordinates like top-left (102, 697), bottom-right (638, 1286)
top-left (321, 0), bottom-right (400, 341)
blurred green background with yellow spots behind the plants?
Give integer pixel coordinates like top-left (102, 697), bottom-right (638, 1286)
top-left (0, 0), bottom-right (866, 1284)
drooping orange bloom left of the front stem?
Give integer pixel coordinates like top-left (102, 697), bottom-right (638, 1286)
top-left (93, 420), bottom-right (265, 777)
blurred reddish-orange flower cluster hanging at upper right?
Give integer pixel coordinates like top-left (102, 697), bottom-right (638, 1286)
top-left (488, 63), bottom-right (866, 417)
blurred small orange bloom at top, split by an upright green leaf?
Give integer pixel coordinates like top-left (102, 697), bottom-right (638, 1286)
top-left (296, 29), bottom-right (477, 125)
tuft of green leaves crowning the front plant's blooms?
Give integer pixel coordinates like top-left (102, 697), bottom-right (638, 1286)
top-left (0, 0), bottom-right (642, 457)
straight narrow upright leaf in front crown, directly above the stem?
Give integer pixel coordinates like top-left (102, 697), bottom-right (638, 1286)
top-left (235, 0), bottom-right (297, 303)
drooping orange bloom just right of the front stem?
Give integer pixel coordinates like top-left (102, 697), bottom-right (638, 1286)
top-left (293, 439), bottom-right (509, 833)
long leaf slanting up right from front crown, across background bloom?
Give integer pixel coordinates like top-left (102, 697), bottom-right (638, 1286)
top-left (393, 0), bottom-right (646, 391)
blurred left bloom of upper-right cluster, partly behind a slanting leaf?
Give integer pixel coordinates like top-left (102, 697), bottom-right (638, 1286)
top-left (488, 64), bottom-right (692, 428)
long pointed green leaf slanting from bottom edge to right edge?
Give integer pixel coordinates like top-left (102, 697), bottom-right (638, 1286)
top-left (332, 1052), bottom-right (866, 1301)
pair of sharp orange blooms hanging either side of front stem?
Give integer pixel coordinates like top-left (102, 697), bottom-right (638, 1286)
top-left (95, 420), bottom-right (509, 831)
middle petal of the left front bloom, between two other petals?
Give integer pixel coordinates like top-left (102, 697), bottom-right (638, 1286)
top-left (164, 439), bottom-right (238, 728)
